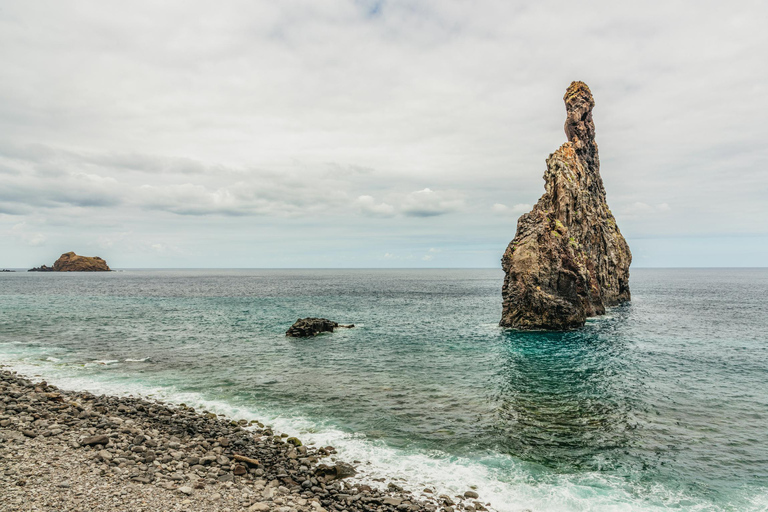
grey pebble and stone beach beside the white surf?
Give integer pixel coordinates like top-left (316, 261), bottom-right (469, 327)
top-left (0, 370), bottom-right (496, 512)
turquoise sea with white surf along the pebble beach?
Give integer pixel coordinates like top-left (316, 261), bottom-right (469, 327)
top-left (0, 269), bottom-right (768, 511)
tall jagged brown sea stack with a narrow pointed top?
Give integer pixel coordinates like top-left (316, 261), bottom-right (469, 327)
top-left (500, 82), bottom-right (632, 330)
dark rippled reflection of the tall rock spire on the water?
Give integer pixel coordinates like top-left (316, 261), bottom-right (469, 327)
top-left (495, 312), bottom-right (642, 472)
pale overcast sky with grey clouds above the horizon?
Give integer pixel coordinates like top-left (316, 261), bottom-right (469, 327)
top-left (0, 0), bottom-right (768, 268)
